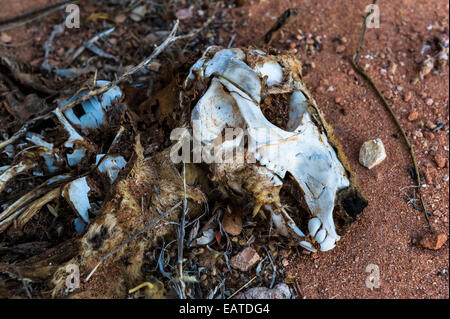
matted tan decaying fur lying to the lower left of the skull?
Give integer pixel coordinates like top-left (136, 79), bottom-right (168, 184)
top-left (52, 140), bottom-right (205, 298)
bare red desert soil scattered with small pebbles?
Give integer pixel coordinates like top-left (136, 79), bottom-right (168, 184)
top-left (0, 0), bottom-right (449, 299)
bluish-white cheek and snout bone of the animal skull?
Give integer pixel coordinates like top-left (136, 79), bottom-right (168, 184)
top-left (220, 79), bottom-right (350, 245)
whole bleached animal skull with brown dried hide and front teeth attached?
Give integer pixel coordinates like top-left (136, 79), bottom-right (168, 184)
top-left (185, 46), bottom-right (367, 251)
